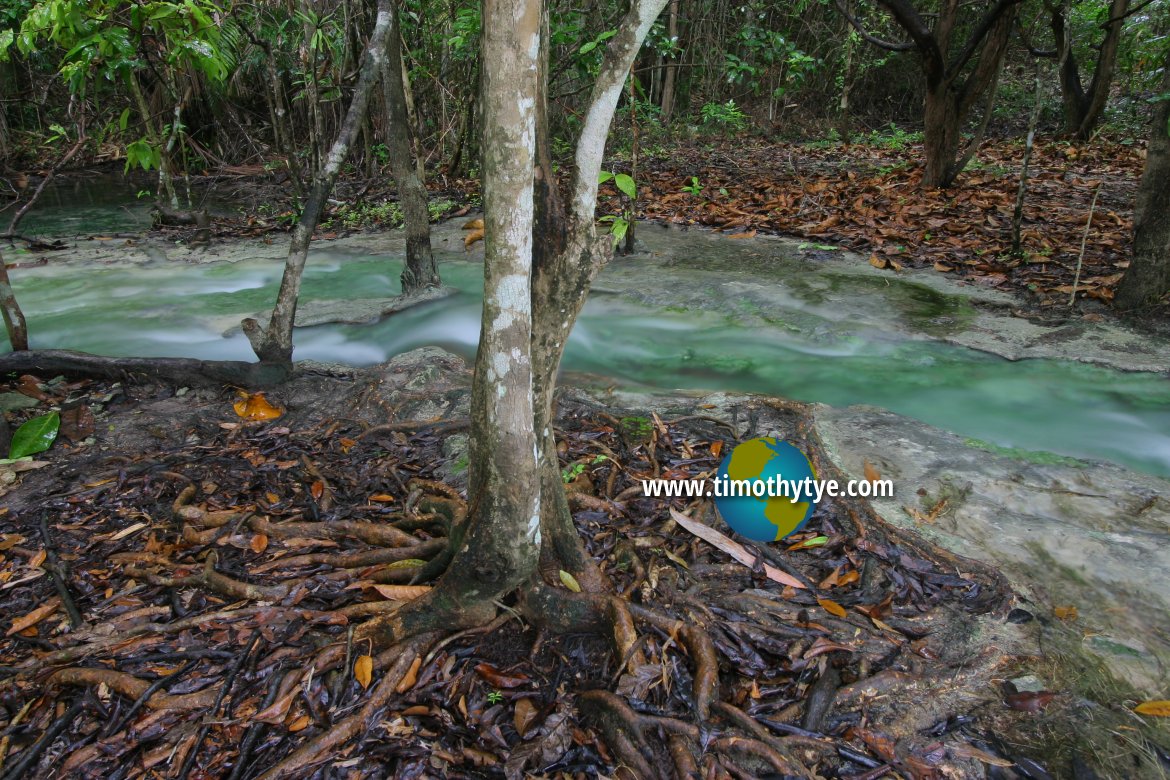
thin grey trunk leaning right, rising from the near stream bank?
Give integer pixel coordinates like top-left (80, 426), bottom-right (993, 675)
top-left (242, 0), bottom-right (393, 364)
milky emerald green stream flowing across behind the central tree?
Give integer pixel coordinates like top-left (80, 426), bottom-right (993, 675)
top-left (12, 251), bottom-right (1170, 476)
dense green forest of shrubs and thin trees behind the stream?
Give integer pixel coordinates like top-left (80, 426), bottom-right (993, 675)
top-left (0, 0), bottom-right (1170, 191)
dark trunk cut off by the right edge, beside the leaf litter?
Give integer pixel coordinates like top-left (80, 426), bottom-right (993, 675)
top-left (1114, 56), bottom-right (1170, 309)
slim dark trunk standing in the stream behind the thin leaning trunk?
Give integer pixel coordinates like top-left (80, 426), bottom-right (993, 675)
top-left (381, 0), bottom-right (440, 295)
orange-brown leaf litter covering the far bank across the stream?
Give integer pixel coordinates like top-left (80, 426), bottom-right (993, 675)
top-left (139, 136), bottom-right (1163, 325)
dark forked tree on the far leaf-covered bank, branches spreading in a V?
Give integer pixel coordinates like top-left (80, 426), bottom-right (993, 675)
top-left (837, 0), bottom-right (1021, 187)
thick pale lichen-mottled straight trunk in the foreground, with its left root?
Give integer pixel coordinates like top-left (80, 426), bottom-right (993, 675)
top-left (356, 0), bottom-right (541, 644)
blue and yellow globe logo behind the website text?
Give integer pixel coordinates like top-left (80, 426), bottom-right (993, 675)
top-left (715, 436), bottom-right (817, 541)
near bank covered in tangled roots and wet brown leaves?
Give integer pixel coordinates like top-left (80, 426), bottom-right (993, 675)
top-left (0, 350), bottom-right (1170, 780)
